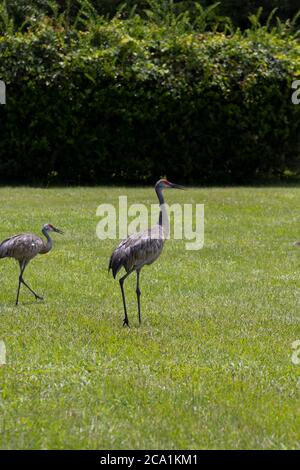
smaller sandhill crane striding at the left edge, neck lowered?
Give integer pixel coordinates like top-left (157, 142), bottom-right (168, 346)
top-left (0, 224), bottom-right (63, 305)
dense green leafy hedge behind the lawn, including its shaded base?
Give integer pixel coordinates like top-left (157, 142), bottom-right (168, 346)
top-left (0, 2), bottom-right (300, 184)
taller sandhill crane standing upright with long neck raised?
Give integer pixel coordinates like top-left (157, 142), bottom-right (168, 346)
top-left (108, 179), bottom-right (184, 326)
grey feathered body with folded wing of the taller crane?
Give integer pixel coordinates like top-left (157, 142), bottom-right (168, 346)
top-left (108, 227), bottom-right (164, 278)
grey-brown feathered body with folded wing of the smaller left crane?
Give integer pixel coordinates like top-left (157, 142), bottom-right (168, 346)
top-left (0, 233), bottom-right (44, 260)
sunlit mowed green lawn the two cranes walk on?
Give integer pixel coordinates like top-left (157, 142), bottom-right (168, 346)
top-left (0, 187), bottom-right (300, 449)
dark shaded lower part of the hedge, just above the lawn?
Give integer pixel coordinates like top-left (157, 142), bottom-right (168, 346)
top-left (0, 80), bottom-right (299, 184)
